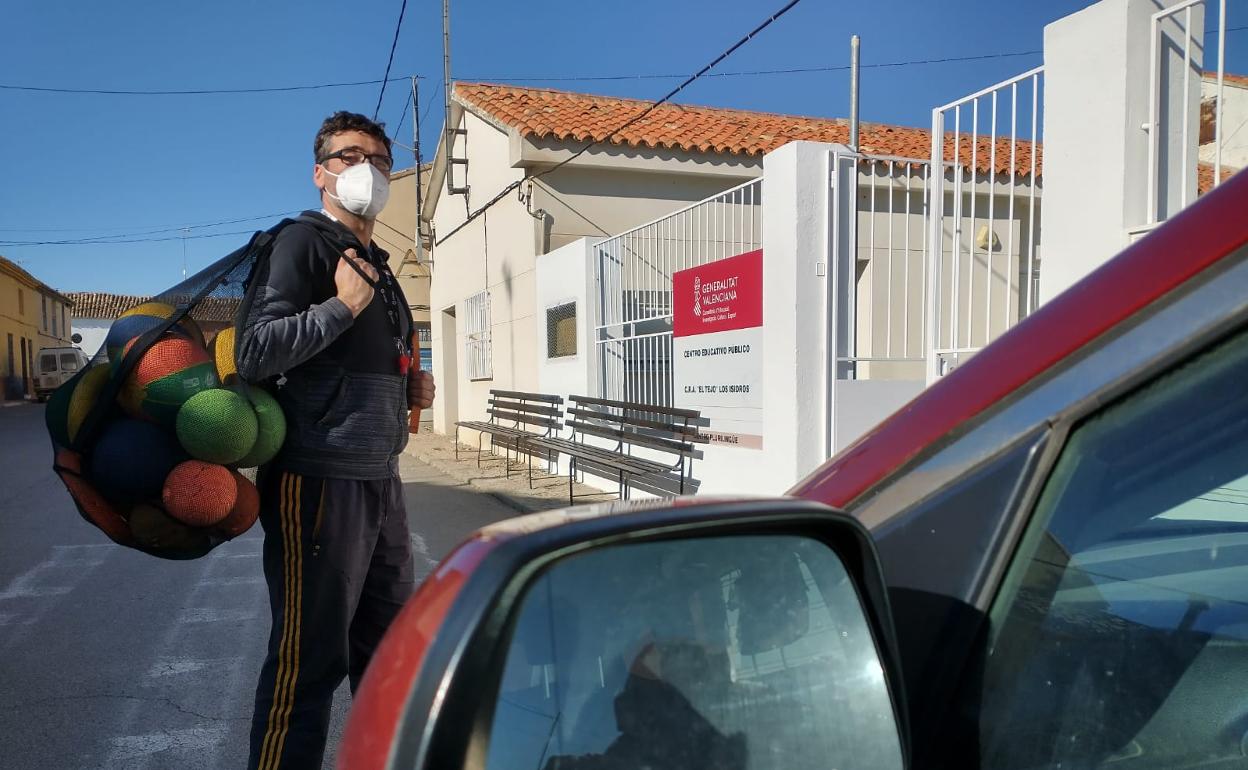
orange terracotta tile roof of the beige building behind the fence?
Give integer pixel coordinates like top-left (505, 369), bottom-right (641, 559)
top-left (454, 82), bottom-right (1041, 175)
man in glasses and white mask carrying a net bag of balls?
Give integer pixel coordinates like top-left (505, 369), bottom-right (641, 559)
top-left (238, 112), bottom-right (433, 770)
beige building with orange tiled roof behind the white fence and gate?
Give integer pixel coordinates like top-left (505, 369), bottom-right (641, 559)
top-left (422, 84), bottom-right (1043, 432)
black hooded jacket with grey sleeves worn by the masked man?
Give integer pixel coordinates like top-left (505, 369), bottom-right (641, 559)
top-left (237, 211), bottom-right (412, 479)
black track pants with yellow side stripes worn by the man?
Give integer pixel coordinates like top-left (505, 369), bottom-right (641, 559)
top-left (247, 470), bottom-right (414, 770)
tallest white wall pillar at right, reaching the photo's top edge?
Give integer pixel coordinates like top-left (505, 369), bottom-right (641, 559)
top-left (1040, 0), bottom-right (1203, 302)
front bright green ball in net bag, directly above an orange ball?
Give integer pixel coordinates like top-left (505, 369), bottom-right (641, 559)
top-left (177, 388), bottom-right (258, 465)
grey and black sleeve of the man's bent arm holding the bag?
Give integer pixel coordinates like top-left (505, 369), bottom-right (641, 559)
top-left (237, 226), bottom-right (354, 382)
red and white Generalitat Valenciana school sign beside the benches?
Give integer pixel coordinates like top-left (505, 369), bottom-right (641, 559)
top-left (671, 250), bottom-right (763, 449)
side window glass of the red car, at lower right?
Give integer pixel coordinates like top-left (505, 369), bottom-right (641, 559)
top-left (968, 329), bottom-right (1248, 769)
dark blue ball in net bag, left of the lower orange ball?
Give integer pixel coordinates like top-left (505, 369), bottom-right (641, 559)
top-left (87, 418), bottom-right (186, 504)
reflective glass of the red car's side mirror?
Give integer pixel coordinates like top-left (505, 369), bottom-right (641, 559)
top-left (485, 535), bottom-right (901, 770)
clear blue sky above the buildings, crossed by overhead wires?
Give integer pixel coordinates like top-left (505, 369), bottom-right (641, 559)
top-left (0, 0), bottom-right (1248, 293)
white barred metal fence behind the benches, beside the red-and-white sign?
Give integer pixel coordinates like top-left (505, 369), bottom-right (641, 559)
top-left (594, 180), bottom-right (763, 406)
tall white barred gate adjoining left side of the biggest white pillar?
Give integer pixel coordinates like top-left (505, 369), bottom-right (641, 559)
top-left (925, 67), bottom-right (1043, 383)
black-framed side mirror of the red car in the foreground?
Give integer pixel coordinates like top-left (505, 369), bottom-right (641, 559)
top-left (339, 499), bottom-right (907, 770)
